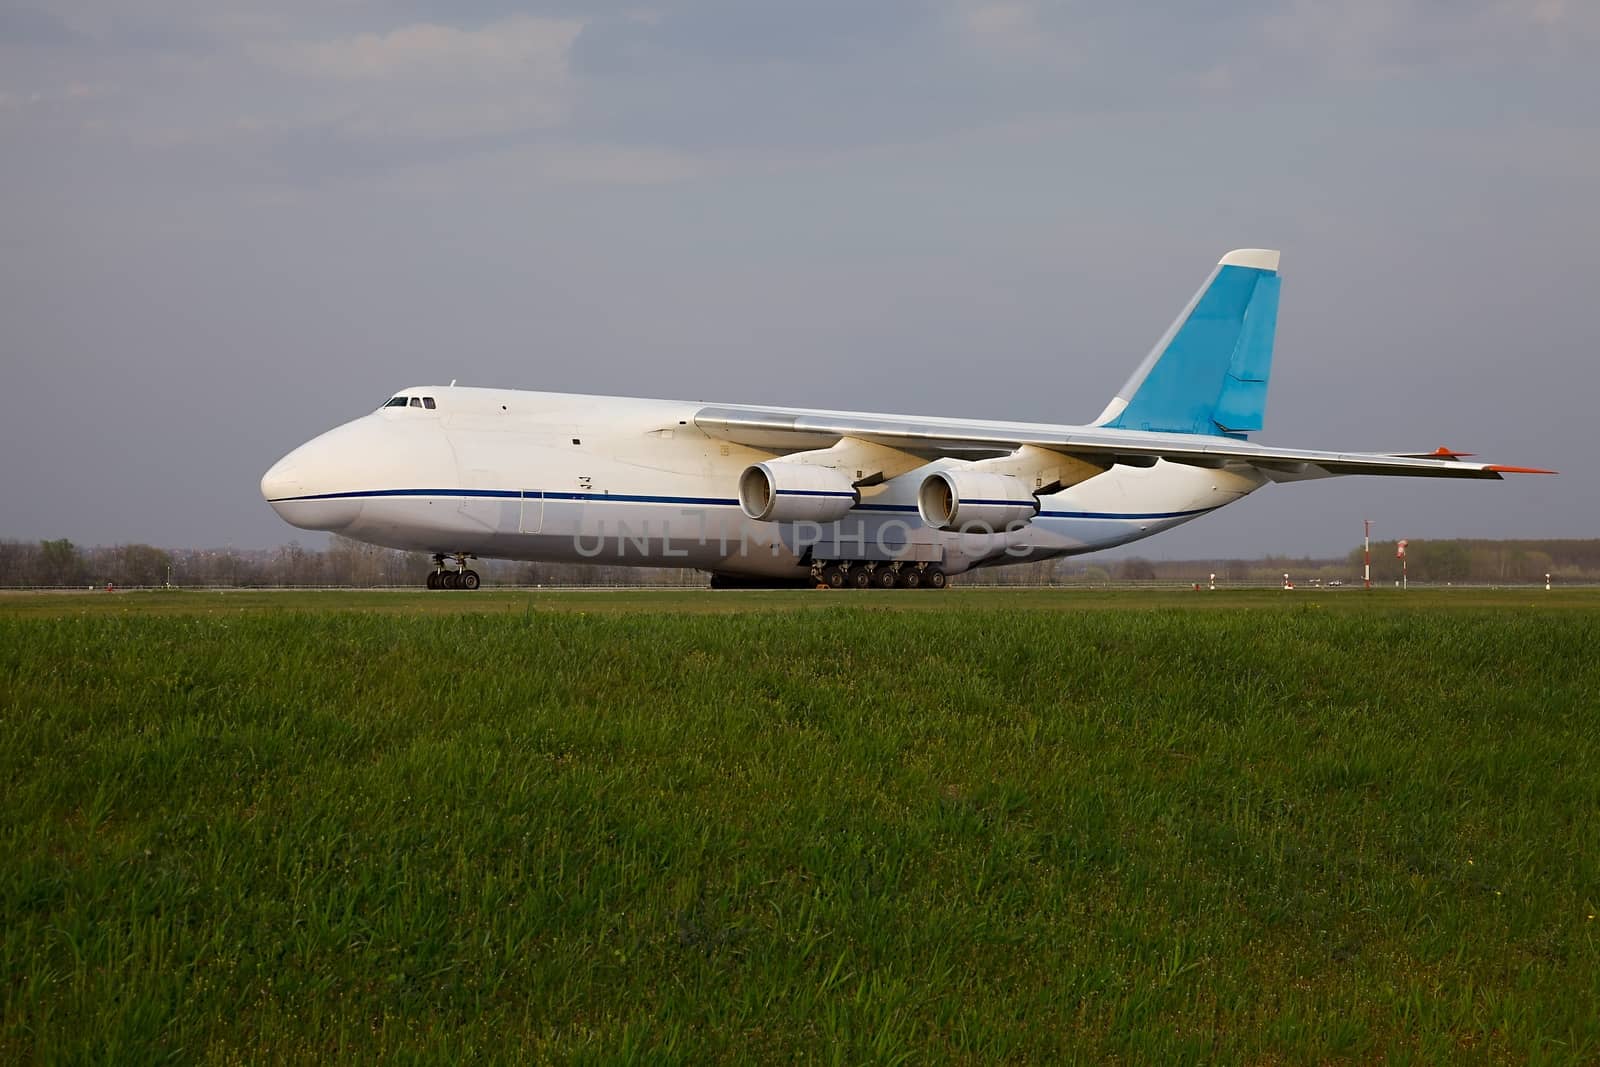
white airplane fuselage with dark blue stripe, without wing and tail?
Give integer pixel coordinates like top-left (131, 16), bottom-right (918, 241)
top-left (262, 387), bottom-right (1266, 579)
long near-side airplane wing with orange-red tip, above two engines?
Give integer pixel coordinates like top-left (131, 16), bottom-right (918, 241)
top-left (694, 405), bottom-right (1555, 482)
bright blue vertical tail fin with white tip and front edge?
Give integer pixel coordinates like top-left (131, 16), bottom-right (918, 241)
top-left (1096, 248), bottom-right (1278, 437)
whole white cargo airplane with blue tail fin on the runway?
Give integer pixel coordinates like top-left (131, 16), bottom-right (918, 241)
top-left (261, 248), bottom-right (1549, 589)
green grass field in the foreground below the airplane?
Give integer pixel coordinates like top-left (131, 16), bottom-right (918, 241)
top-left (0, 589), bottom-right (1600, 1064)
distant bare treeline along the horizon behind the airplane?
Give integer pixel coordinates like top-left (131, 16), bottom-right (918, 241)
top-left (0, 537), bottom-right (1600, 589)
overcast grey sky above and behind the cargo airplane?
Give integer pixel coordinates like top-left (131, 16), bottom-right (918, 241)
top-left (0, 0), bottom-right (1600, 558)
